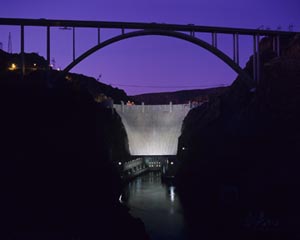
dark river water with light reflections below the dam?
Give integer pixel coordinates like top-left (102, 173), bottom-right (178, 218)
top-left (122, 172), bottom-right (187, 240)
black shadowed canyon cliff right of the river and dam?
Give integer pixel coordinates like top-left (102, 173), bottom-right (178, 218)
top-left (176, 36), bottom-right (300, 239)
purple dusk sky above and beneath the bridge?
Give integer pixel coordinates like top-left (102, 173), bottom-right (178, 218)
top-left (0, 0), bottom-right (300, 95)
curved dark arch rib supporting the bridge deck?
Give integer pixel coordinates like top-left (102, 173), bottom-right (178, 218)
top-left (60, 30), bottom-right (254, 88)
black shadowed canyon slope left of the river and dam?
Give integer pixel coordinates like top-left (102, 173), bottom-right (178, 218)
top-left (0, 76), bottom-right (148, 240)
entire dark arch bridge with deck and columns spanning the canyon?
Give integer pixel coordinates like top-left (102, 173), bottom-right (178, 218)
top-left (0, 18), bottom-right (296, 88)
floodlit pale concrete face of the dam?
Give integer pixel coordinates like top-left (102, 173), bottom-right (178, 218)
top-left (114, 104), bottom-right (190, 156)
